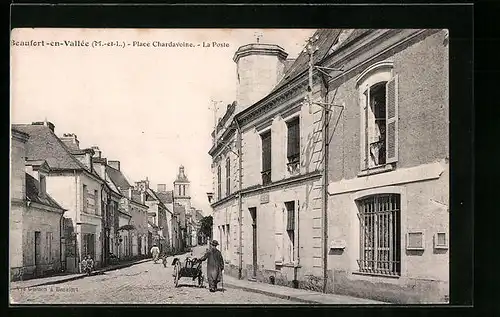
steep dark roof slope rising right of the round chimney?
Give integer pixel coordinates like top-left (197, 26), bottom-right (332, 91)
top-left (271, 29), bottom-right (342, 93)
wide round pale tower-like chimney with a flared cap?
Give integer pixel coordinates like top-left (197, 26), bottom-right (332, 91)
top-left (233, 43), bottom-right (288, 113)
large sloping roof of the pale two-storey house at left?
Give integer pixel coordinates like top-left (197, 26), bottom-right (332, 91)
top-left (13, 124), bottom-right (87, 170)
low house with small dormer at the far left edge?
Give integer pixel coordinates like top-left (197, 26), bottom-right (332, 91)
top-left (9, 128), bottom-right (65, 280)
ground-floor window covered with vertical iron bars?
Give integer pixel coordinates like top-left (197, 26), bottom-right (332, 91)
top-left (357, 194), bottom-right (401, 276)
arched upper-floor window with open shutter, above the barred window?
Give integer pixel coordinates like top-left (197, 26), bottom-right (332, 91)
top-left (358, 62), bottom-right (398, 170)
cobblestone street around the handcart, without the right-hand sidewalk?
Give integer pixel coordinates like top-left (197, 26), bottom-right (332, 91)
top-left (11, 249), bottom-right (297, 304)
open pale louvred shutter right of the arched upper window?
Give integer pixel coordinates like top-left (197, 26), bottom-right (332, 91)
top-left (385, 75), bottom-right (398, 163)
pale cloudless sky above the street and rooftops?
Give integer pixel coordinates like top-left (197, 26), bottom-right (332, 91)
top-left (10, 29), bottom-right (314, 215)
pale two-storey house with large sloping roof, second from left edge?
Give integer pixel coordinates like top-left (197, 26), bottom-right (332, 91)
top-left (13, 122), bottom-right (104, 272)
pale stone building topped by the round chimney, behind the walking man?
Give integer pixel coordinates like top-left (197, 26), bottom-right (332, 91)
top-left (209, 44), bottom-right (321, 285)
